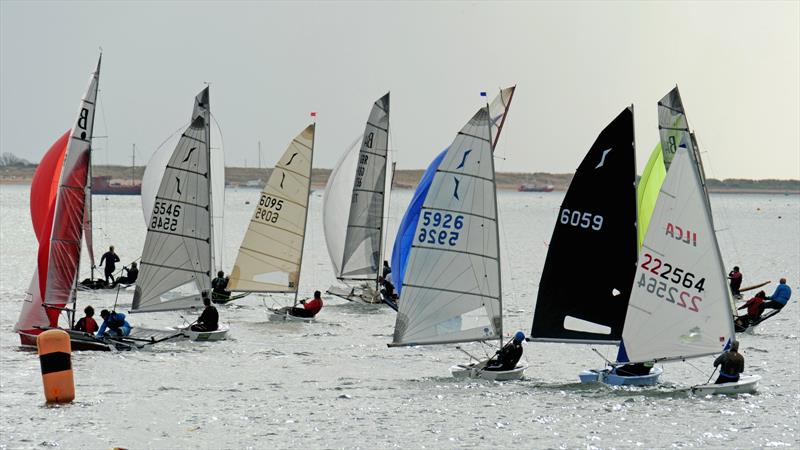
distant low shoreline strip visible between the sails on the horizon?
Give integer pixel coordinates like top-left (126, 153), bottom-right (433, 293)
top-left (0, 165), bottom-right (800, 195)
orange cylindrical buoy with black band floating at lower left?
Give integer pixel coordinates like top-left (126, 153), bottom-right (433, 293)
top-left (36, 330), bottom-right (75, 403)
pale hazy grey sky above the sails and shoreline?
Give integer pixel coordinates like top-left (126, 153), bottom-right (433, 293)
top-left (0, 0), bottom-right (800, 179)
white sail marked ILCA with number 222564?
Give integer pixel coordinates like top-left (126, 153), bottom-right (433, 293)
top-left (620, 148), bottom-right (734, 362)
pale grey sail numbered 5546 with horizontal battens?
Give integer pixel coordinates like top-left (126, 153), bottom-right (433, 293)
top-left (132, 88), bottom-right (213, 312)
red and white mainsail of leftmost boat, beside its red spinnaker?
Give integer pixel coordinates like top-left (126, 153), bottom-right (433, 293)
top-left (44, 56), bottom-right (102, 307)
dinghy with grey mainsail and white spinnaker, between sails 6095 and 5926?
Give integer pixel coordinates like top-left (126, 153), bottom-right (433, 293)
top-left (322, 93), bottom-right (392, 304)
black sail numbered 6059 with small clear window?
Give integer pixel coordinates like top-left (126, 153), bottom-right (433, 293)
top-left (531, 106), bottom-right (638, 344)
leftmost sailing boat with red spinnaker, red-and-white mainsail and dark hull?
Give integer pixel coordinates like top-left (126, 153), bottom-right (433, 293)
top-left (14, 55), bottom-right (139, 350)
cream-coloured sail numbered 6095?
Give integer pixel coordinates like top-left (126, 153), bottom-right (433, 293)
top-left (228, 124), bottom-right (315, 292)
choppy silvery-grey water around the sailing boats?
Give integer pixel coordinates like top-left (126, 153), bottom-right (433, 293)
top-left (0, 186), bottom-right (800, 448)
